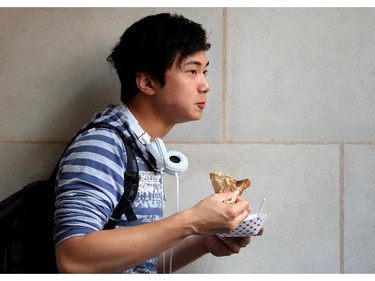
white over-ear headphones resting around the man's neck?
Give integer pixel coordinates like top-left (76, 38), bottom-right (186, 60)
top-left (124, 106), bottom-right (189, 175)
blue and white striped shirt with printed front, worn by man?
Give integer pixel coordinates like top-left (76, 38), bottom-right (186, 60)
top-left (55, 104), bottom-right (165, 273)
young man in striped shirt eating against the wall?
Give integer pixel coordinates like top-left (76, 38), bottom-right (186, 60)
top-left (55, 14), bottom-right (262, 273)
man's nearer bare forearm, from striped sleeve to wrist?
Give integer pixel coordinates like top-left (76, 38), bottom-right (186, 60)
top-left (56, 212), bottom-right (192, 273)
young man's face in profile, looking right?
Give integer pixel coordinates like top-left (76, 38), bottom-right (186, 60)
top-left (155, 51), bottom-right (210, 125)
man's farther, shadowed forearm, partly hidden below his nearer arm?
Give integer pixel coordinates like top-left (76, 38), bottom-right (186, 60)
top-left (158, 236), bottom-right (208, 273)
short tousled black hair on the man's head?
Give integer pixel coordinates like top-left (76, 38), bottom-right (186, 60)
top-left (107, 13), bottom-right (211, 103)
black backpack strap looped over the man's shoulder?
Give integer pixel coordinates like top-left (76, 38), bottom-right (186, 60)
top-left (49, 122), bottom-right (139, 229)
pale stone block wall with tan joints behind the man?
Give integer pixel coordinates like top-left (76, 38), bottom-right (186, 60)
top-left (0, 8), bottom-right (375, 273)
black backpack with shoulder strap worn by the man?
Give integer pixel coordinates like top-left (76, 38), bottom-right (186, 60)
top-left (0, 123), bottom-right (139, 273)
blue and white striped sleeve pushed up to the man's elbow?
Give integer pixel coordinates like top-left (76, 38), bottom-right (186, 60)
top-left (55, 128), bottom-right (126, 245)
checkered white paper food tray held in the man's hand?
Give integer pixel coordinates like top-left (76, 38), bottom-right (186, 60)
top-left (216, 213), bottom-right (268, 237)
